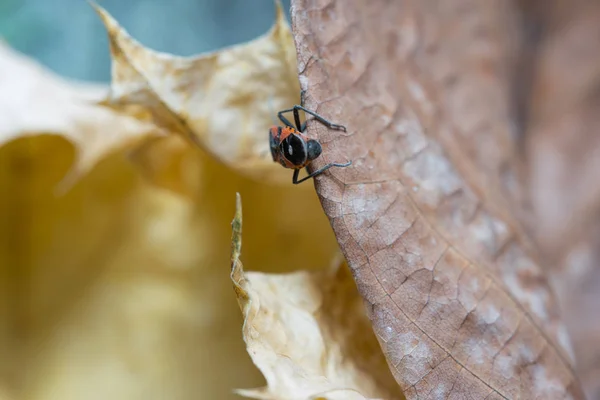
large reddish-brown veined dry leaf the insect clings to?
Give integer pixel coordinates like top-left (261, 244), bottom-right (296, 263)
top-left (292, 0), bottom-right (583, 399)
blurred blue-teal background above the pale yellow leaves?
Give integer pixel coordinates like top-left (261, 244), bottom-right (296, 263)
top-left (0, 0), bottom-right (290, 82)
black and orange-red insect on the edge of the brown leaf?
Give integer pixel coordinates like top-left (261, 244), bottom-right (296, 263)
top-left (269, 92), bottom-right (352, 185)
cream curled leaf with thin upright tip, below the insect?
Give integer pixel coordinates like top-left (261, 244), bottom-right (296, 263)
top-left (231, 194), bottom-right (403, 400)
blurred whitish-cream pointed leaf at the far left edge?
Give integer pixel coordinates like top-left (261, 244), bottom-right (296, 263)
top-left (0, 41), bottom-right (164, 190)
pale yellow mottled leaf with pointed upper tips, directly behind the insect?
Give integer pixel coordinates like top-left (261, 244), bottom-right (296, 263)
top-left (94, 2), bottom-right (300, 186)
